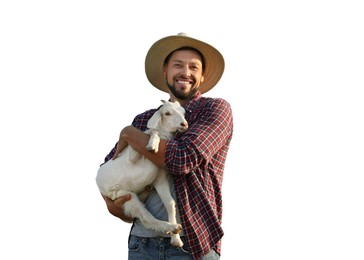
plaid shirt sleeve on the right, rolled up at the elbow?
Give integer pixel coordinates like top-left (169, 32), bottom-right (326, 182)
top-left (165, 99), bottom-right (233, 175)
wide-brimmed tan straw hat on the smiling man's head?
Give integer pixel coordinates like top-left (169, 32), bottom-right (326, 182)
top-left (145, 33), bottom-right (225, 93)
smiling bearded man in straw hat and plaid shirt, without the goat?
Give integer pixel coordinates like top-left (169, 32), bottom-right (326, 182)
top-left (104, 34), bottom-right (233, 260)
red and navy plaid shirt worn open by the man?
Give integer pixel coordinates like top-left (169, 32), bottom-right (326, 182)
top-left (105, 93), bottom-right (233, 259)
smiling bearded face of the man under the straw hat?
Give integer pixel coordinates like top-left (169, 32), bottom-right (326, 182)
top-left (164, 50), bottom-right (204, 100)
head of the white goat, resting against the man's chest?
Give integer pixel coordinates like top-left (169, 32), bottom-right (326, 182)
top-left (147, 100), bottom-right (188, 133)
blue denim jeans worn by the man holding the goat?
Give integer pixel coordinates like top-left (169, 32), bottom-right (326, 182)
top-left (128, 235), bottom-right (220, 260)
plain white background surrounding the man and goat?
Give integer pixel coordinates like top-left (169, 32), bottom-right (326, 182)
top-left (0, 0), bottom-right (364, 260)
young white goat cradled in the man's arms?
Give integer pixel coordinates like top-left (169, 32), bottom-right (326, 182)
top-left (96, 100), bottom-right (188, 247)
